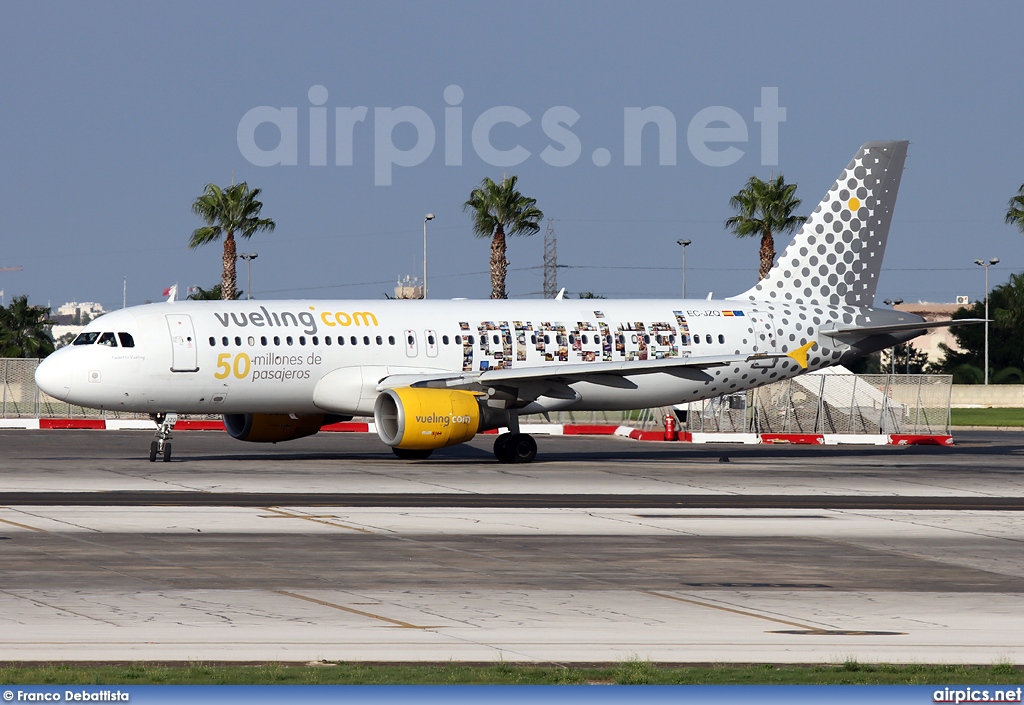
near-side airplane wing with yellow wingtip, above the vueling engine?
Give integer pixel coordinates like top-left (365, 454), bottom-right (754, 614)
top-left (377, 341), bottom-right (816, 391)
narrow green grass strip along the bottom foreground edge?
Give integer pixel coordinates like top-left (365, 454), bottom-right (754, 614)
top-left (0, 659), bottom-right (1024, 686)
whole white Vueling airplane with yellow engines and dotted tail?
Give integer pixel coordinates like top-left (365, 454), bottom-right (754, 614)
top-left (36, 141), bottom-right (973, 463)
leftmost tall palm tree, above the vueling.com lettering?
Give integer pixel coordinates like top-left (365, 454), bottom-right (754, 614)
top-left (188, 181), bottom-right (275, 301)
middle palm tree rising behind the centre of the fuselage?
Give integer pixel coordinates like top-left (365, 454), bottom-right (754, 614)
top-left (462, 176), bottom-right (544, 298)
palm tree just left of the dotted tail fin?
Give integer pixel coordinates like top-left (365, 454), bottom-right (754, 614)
top-left (725, 174), bottom-right (807, 280)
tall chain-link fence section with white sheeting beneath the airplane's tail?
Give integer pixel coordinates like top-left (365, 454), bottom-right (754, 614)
top-left (686, 373), bottom-right (952, 434)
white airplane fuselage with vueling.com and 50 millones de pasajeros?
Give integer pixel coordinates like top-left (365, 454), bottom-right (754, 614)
top-left (37, 299), bottom-right (912, 414)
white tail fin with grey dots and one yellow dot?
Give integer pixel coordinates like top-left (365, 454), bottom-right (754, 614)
top-left (732, 141), bottom-right (909, 306)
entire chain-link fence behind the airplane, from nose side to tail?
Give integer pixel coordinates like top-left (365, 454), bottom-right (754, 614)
top-left (6, 359), bottom-right (952, 434)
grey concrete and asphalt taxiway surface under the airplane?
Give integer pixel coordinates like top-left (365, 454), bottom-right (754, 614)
top-left (0, 431), bottom-right (1024, 664)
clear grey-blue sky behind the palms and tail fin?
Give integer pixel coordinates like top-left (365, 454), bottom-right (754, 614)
top-left (0, 1), bottom-right (1024, 307)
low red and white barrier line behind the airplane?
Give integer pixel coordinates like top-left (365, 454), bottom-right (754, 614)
top-left (0, 418), bottom-right (953, 446)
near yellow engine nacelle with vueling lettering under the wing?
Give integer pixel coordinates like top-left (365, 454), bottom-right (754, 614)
top-left (374, 387), bottom-right (481, 450)
